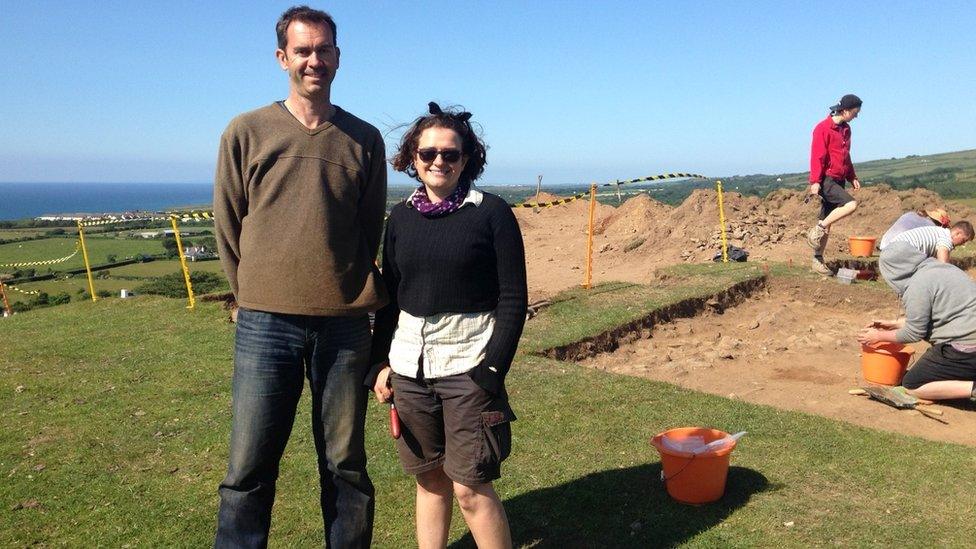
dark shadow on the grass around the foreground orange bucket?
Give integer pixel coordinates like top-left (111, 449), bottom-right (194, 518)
top-left (451, 463), bottom-right (775, 549)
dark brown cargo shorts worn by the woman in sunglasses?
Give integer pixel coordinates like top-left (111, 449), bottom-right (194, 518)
top-left (390, 373), bottom-right (515, 486)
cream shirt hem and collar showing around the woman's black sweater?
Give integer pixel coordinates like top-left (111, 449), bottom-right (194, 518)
top-left (389, 185), bottom-right (495, 379)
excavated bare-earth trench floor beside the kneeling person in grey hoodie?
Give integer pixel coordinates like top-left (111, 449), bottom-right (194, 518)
top-left (582, 277), bottom-right (976, 446)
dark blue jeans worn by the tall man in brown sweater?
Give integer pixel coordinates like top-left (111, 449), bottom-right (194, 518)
top-left (214, 308), bottom-right (374, 548)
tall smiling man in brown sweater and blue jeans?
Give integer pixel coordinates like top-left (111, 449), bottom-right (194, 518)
top-left (214, 6), bottom-right (387, 547)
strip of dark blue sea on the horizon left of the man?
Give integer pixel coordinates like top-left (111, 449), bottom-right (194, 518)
top-left (0, 183), bottom-right (213, 220)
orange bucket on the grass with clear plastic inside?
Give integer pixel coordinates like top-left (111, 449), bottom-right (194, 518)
top-left (651, 427), bottom-right (736, 504)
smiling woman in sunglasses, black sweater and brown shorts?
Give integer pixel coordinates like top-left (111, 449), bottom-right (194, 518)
top-left (372, 103), bottom-right (528, 548)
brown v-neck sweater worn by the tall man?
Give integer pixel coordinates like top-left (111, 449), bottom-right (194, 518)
top-left (214, 103), bottom-right (387, 316)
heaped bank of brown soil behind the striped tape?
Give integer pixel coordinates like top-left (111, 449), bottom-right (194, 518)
top-left (515, 185), bottom-right (974, 301)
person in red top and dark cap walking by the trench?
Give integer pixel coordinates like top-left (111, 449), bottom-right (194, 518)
top-left (807, 94), bottom-right (861, 276)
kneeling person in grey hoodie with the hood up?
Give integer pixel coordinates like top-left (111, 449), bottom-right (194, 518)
top-left (857, 241), bottom-right (976, 400)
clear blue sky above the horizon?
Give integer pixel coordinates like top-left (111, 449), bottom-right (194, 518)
top-left (0, 0), bottom-right (976, 184)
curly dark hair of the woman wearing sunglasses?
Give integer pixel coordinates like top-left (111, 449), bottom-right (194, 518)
top-left (390, 101), bottom-right (488, 183)
